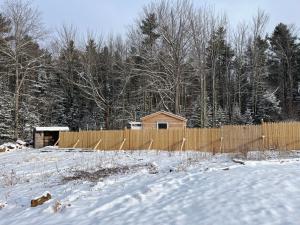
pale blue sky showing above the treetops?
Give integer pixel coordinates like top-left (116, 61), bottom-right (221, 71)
top-left (0, 0), bottom-right (300, 35)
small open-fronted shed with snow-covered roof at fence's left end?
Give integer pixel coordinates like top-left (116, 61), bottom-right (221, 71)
top-left (33, 127), bottom-right (70, 148)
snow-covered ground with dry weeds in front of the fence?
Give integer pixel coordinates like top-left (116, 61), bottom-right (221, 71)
top-left (0, 148), bottom-right (300, 225)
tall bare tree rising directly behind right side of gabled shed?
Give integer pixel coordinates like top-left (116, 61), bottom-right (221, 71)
top-left (156, 0), bottom-right (193, 114)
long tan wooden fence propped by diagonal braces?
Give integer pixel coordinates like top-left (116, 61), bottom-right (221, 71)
top-left (59, 122), bottom-right (300, 153)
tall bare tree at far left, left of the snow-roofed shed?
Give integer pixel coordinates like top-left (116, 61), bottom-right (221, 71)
top-left (0, 0), bottom-right (45, 138)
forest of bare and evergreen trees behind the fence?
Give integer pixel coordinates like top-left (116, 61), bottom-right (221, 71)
top-left (0, 0), bottom-right (300, 141)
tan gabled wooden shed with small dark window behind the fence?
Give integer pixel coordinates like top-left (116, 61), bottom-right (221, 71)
top-left (141, 111), bottom-right (187, 129)
